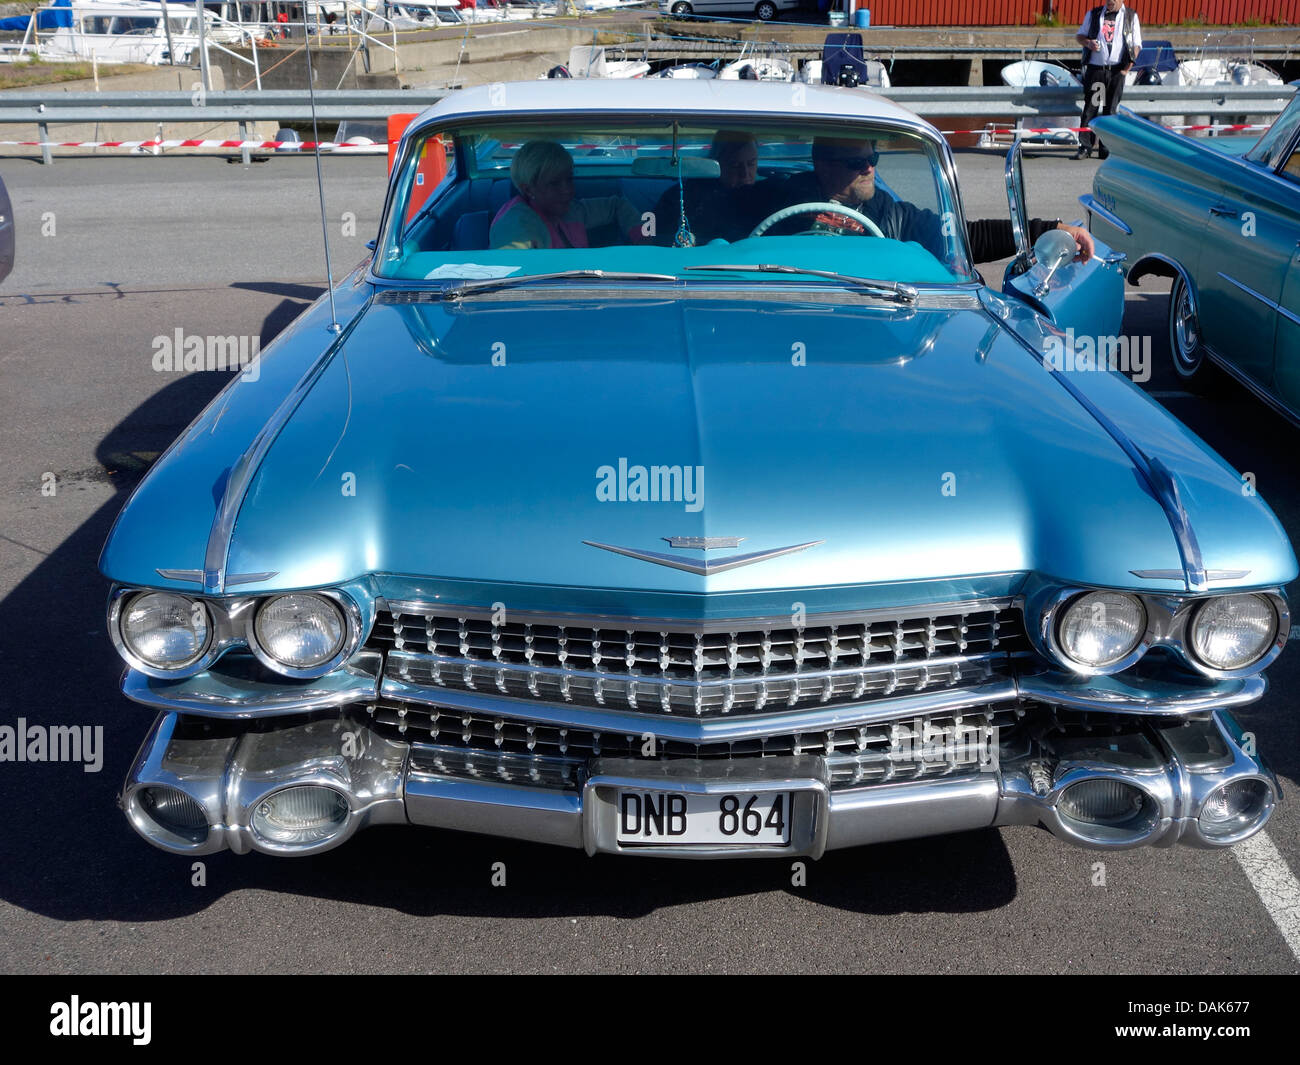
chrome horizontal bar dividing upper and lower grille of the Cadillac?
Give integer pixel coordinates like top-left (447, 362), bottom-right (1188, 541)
top-left (380, 676), bottom-right (1017, 744)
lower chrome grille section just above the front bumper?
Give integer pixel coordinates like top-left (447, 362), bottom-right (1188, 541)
top-left (367, 700), bottom-right (1023, 787)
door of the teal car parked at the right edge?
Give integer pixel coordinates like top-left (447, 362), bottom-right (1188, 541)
top-left (1196, 152), bottom-right (1300, 388)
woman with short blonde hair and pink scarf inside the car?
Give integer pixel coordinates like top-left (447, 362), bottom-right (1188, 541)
top-left (488, 140), bottom-right (645, 248)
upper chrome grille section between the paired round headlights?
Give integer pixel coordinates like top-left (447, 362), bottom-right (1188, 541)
top-left (368, 601), bottom-right (1028, 717)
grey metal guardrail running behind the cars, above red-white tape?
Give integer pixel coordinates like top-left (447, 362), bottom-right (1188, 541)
top-left (0, 85), bottom-right (1296, 163)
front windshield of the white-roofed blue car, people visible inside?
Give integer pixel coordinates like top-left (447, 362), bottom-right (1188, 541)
top-left (374, 116), bottom-right (972, 283)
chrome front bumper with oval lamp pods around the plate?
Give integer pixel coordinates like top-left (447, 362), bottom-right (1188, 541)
top-left (121, 709), bottom-right (1282, 858)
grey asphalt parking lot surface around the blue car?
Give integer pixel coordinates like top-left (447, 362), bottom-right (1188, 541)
top-left (0, 150), bottom-right (1300, 974)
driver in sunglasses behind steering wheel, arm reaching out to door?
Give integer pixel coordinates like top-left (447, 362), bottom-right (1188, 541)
top-left (764, 137), bottom-right (1093, 263)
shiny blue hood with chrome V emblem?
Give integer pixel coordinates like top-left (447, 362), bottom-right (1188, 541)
top-left (180, 287), bottom-right (1275, 592)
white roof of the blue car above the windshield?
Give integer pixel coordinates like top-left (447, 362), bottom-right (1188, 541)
top-left (411, 78), bottom-right (933, 137)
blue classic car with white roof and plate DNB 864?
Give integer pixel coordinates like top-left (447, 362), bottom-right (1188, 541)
top-left (100, 81), bottom-right (1296, 857)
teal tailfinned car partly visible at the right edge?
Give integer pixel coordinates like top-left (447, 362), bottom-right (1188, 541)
top-left (1082, 96), bottom-right (1300, 423)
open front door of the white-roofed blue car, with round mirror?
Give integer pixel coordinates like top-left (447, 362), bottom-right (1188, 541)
top-left (1002, 142), bottom-right (1125, 339)
